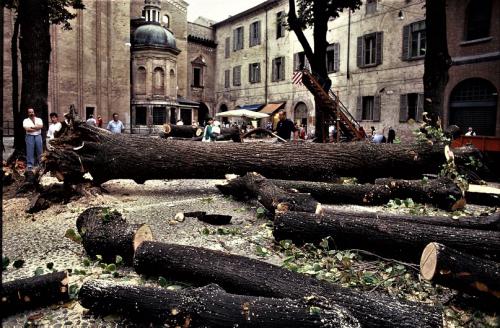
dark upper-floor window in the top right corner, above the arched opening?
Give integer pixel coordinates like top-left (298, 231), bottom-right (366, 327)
top-left (465, 0), bottom-right (492, 41)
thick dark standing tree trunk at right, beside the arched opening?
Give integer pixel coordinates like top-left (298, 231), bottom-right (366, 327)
top-left (424, 0), bottom-right (451, 128)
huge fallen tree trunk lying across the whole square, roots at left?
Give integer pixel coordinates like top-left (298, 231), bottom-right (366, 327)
top-left (44, 122), bottom-right (472, 184)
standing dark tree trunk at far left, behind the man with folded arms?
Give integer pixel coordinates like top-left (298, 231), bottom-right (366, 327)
top-left (18, 0), bottom-right (51, 140)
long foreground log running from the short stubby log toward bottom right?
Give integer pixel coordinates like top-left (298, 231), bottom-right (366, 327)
top-left (134, 241), bottom-right (442, 327)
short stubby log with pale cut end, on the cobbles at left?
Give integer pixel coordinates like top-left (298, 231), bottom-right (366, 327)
top-left (76, 207), bottom-right (153, 263)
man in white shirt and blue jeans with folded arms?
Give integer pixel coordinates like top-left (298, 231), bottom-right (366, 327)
top-left (23, 108), bottom-right (43, 171)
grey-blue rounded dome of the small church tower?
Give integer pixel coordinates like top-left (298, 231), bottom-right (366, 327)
top-left (133, 22), bottom-right (177, 49)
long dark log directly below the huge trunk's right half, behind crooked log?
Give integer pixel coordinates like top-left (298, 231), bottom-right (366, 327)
top-left (270, 178), bottom-right (465, 211)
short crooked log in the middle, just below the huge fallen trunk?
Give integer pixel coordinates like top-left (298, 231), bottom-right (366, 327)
top-left (217, 172), bottom-right (321, 213)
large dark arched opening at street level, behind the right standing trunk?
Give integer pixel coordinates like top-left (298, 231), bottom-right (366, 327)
top-left (449, 78), bottom-right (497, 136)
